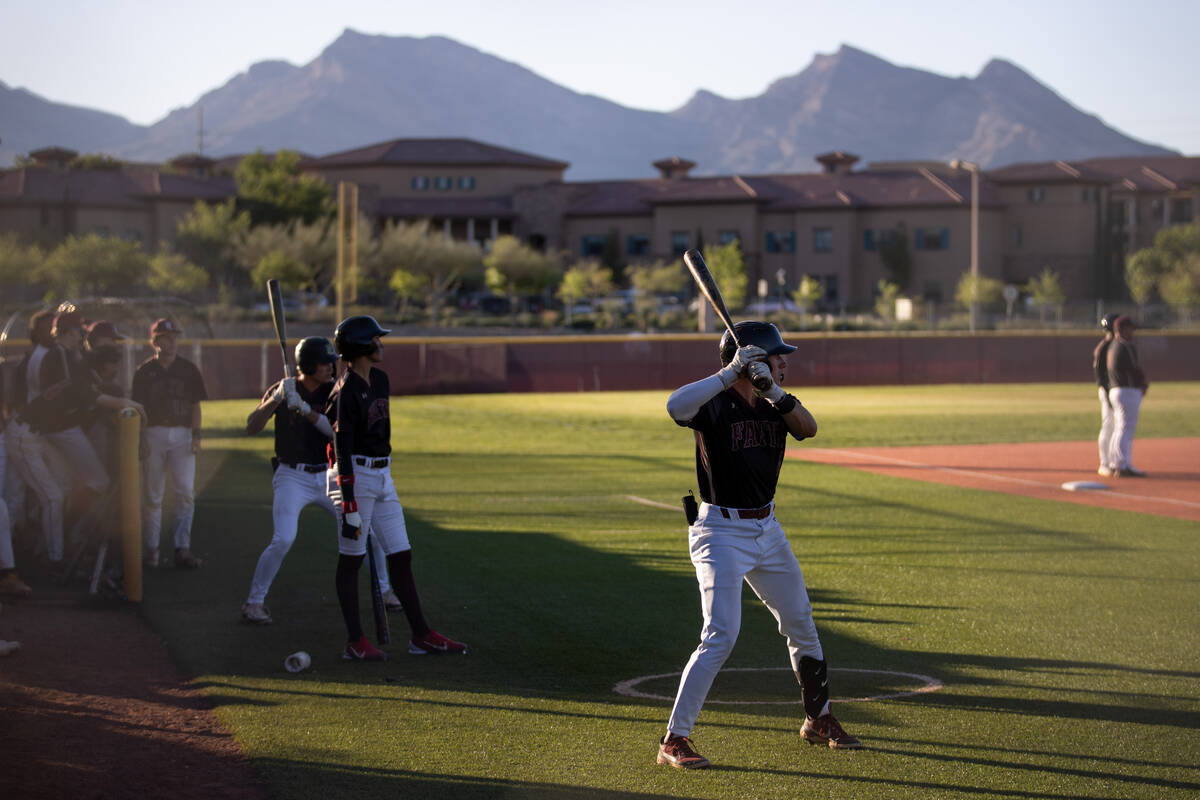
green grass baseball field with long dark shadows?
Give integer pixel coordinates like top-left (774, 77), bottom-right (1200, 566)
top-left (144, 384), bottom-right (1200, 800)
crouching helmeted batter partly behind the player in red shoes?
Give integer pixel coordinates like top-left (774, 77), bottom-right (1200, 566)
top-left (241, 336), bottom-right (401, 625)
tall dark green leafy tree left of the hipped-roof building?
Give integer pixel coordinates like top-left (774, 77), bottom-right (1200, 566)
top-left (234, 150), bottom-right (334, 225)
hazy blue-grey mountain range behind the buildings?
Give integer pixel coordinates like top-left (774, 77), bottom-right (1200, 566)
top-left (0, 30), bottom-right (1177, 180)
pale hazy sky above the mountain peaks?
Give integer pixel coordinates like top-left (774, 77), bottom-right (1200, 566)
top-left (0, 0), bottom-right (1200, 155)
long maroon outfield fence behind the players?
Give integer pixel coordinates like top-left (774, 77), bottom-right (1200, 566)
top-left (4, 331), bottom-right (1200, 399)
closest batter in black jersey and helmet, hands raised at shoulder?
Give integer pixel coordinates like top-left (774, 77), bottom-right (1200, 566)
top-left (658, 321), bottom-right (862, 769)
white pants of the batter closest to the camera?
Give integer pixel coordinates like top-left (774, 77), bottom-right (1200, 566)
top-left (667, 503), bottom-right (824, 736)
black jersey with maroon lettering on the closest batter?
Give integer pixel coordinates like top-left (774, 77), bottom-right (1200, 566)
top-left (677, 390), bottom-right (801, 509)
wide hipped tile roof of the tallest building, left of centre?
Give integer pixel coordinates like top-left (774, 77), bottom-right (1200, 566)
top-left (301, 139), bottom-right (570, 170)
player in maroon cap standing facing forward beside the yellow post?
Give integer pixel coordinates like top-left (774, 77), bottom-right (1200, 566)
top-left (133, 319), bottom-right (208, 570)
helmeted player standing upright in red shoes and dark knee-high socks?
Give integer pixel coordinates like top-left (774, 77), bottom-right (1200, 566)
top-left (325, 317), bottom-right (467, 661)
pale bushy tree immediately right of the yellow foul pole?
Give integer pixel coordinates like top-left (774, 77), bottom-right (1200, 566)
top-left (378, 221), bottom-right (482, 325)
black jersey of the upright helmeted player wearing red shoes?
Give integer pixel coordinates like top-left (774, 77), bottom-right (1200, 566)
top-left (325, 367), bottom-right (391, 475)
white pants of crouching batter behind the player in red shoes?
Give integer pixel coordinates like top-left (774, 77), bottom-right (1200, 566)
top-left (246, 464), bottom-right (391, 603)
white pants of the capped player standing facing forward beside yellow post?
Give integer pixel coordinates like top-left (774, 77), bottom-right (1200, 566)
top-left (142, 425), bottom-right (196, 551)
